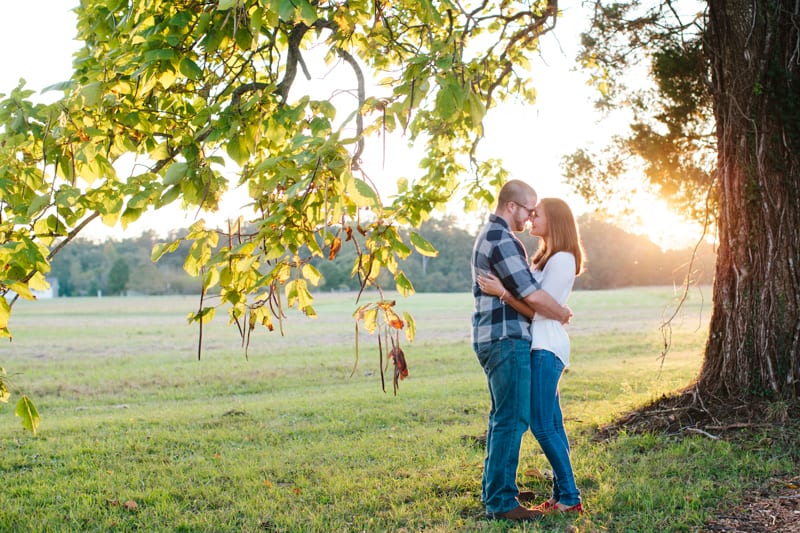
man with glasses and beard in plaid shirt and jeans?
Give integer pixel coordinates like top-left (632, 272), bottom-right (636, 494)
top-left (472, 180), bottom-right (572, 521)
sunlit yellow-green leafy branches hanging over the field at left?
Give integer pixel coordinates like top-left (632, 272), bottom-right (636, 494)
top-left (0, 0), bottom-right (557, 428)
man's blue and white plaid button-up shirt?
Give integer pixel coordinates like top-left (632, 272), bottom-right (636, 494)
top-left (472, 214), bottom-right (541, 346)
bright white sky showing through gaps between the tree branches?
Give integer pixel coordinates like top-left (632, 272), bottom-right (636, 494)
top-left (0, 0), bottom-right (696, 248)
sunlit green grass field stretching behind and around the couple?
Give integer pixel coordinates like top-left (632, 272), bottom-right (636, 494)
top-left (0, 288), bottom-right (791, 532)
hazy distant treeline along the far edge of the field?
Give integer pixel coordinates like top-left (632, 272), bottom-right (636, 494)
top-left (49, 215), bottom-right (715, 296)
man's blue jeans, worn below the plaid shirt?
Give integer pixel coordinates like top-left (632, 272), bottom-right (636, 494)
top-left (475, 339), bottom-right (531, 514)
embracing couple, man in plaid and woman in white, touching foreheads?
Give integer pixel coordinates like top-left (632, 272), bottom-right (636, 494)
top-left (472, 180), bottom-right (584, 521)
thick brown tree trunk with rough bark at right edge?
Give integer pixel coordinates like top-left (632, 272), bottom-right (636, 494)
top-left (698, 0), bottom-right (800, 400)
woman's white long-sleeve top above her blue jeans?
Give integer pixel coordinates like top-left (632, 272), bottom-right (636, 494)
top-left (531, 252), bottom-right (575, 367)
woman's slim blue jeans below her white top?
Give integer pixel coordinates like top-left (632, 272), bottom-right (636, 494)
top-left (531, 350), bottom-right (581, 506)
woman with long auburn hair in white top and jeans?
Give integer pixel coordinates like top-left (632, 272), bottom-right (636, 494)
top-left (478, 198), bottom-right (584, 513)
